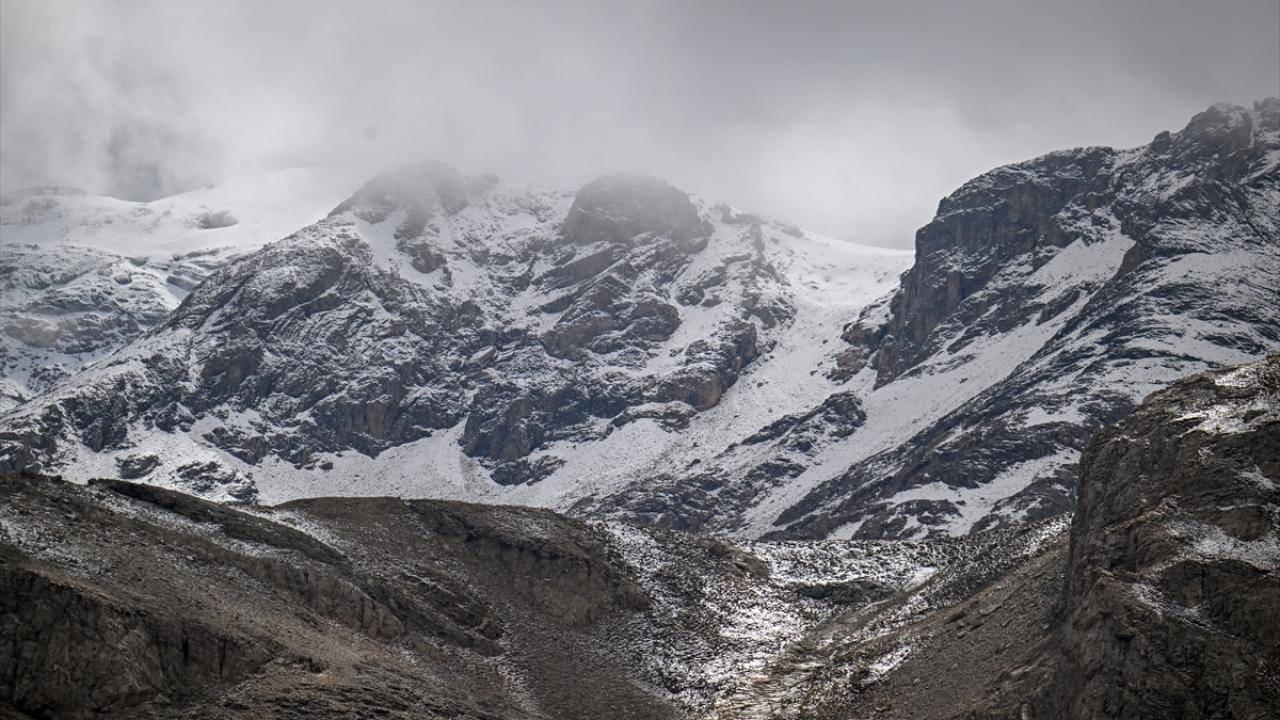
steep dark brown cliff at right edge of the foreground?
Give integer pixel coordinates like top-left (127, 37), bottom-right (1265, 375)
top-left (1037, 356), bottom-right (1280, 719)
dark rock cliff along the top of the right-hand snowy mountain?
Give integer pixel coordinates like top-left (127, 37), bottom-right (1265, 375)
top-left (845, 97), bottom-right (1280, 383)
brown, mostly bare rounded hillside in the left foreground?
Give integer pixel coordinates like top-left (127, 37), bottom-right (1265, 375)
top-left (0, 477), bottom-right (669, 719)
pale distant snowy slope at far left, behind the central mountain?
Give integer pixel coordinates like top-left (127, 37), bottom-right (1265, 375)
top-left (0, 168), bottom-right (371, 409)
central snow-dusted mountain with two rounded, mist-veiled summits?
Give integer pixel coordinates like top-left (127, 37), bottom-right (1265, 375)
top-left (4, 164), bottom-right (909, 509)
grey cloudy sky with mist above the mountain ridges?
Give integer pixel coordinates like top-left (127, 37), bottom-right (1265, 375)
top-left (0, 0), bottom-right (1280, 246)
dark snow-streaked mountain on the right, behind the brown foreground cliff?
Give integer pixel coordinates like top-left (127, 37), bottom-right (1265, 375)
top-left (563, 99), bottom-right (1280, 538)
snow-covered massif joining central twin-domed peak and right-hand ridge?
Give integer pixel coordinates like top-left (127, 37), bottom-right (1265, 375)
top-left (0, 100), bottom-right (1280, 538)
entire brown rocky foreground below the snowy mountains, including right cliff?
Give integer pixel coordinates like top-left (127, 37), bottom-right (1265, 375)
top-left (0, 355), bottom-right (1280, 720)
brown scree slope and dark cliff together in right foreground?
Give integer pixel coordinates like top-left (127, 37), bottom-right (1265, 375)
top-left (815, 355), bottom-right (1280, 720)
